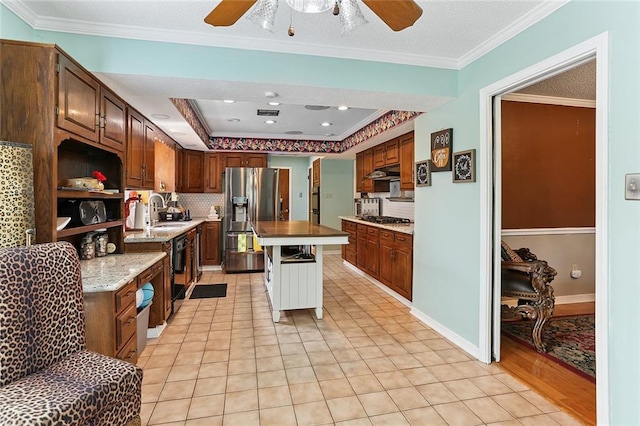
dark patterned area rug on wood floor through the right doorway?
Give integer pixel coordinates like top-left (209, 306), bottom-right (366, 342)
top-left (502, 315), bottom-right (596, 382)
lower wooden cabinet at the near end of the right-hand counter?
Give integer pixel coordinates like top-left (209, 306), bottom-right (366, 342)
top-left (379, 229), bottom-right (413, 300)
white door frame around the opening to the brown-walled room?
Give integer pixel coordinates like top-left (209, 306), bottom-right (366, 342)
top-left (478, 32), bottom-right (609, 424)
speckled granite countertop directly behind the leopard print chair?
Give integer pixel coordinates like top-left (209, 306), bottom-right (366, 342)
top-left (80, 251), bottom-right (167, 293)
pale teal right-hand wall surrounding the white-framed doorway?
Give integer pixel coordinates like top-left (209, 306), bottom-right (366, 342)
top-left (413, 1), bottom-right (640, 425)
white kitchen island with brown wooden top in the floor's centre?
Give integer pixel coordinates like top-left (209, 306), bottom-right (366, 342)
top-left (253, 221), bottom-right (349, 322)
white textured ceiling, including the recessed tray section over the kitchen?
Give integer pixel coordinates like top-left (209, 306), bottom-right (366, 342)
top-left (5, 0), bottom-right (566, 156)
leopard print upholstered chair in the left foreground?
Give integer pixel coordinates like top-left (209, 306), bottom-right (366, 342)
top-left (0, 242), bottom-right (142, 426)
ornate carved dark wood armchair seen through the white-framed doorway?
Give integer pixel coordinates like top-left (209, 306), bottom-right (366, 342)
top-left (501, 241), bottom-right (558, 352)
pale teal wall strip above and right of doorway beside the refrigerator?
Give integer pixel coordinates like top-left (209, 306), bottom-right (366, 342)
top-left (269, 155), bottom-right (309, 220)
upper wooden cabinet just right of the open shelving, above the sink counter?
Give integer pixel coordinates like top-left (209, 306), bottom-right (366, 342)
top-left (125, 108), bottom-right (156, 189)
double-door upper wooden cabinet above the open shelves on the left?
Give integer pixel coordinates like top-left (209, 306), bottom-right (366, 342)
top-left (56, 54), bottom-right (126, 151)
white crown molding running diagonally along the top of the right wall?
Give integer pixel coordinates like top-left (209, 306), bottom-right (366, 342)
top-left (456, 0), bottom-right (570, 69)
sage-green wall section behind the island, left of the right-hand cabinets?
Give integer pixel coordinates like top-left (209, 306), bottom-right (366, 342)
top-left (320, 158), bottom-right (355, 233)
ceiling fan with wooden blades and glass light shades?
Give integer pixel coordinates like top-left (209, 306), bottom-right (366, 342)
top-left (204, 0), bottom-right (422, 35)
